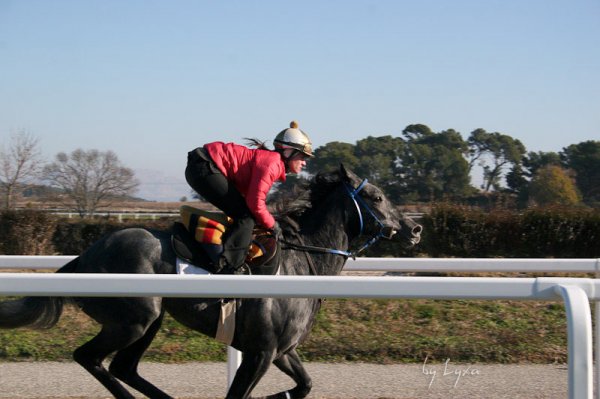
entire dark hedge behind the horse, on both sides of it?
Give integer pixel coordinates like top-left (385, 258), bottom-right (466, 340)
top-left (0, 204), bottom-right (600, 258)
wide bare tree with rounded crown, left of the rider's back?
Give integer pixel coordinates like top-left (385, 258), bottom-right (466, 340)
top-left (44, 149), bottom-right (139, 217)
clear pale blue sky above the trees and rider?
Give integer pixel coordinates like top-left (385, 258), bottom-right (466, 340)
top-left (0, 0), bottom-right (600, 201)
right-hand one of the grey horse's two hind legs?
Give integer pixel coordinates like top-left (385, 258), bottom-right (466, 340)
top-left (108, 313), bottom-right (170, 399)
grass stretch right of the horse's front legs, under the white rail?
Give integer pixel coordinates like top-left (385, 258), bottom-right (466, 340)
top-left (302, 300), bottom-right (567, 363)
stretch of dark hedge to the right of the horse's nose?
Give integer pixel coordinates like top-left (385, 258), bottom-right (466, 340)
top-left (422, 205), bottom-right (600, 258)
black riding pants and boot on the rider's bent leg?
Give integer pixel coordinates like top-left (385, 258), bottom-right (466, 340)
top-left (185, 149), bottom-right (255, 268)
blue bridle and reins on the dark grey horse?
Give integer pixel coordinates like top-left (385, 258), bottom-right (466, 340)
top-left (281, 179), bottom-right (396, 262)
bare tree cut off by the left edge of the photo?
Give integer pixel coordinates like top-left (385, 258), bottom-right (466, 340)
top-left (0, 130), bottom-right (43, 209)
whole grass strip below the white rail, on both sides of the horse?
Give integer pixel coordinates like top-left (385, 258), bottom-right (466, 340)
top-left (0, 299), bottom-right (567, 363)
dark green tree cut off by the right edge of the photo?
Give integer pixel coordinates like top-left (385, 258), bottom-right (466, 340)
top-left (560, 140), bottom-right (600, 204)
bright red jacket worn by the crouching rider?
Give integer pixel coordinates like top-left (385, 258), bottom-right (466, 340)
top-left (204, 141), bottom-right (285, 229)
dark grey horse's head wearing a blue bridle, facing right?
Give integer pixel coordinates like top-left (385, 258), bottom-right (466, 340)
top-left (340, 165), bottom-right (401, 244)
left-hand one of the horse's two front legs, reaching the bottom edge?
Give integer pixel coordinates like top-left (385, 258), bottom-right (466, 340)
top-left (226, 351), bottom-right (274, 399)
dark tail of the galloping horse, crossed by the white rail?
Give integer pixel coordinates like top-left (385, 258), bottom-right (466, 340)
top-left (0, 258), bottom-right (79, 329)
